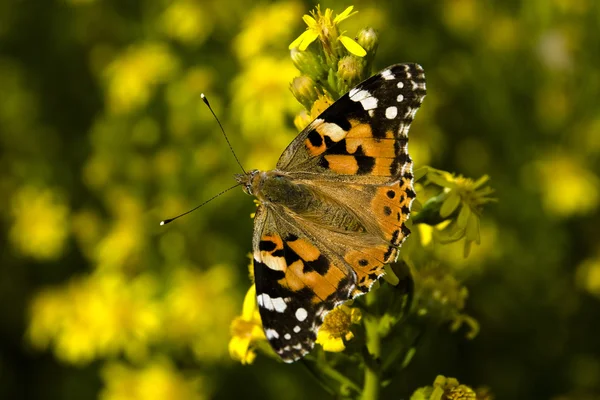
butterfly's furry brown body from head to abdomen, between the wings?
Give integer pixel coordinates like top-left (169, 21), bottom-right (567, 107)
top-left (235, 170), bottom-right (366, 232)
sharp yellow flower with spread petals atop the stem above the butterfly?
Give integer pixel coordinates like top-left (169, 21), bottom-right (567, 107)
top-left (289, 6), bottom-right (367, 57)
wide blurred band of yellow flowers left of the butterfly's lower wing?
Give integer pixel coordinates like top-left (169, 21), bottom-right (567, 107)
top-left (27, 266), bottom-right (235, 364)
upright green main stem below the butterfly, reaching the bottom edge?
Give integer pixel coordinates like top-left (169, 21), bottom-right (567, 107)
top-left (362, 296), bottom-right (381, 400)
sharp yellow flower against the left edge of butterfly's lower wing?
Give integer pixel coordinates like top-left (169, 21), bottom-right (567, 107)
top-left (229, 285), bottom-right (266, 364)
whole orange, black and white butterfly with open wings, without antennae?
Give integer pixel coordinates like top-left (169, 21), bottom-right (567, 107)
top-left (235, 64), bottom-right (426, 363)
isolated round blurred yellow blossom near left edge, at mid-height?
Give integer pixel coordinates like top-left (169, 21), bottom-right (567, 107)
top-left (10, 186), bottom-right (69, 260)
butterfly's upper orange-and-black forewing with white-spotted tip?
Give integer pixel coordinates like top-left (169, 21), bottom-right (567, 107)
top-left (277, 64), bottom-right (426, 182)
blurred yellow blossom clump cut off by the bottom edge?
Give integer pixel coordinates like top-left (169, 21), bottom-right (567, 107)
top-left (100, 359), bottom-right (210, 400)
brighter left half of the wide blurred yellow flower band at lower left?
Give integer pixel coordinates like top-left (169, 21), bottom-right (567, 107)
top-left (27, 274), bottom-right (162, 364)
